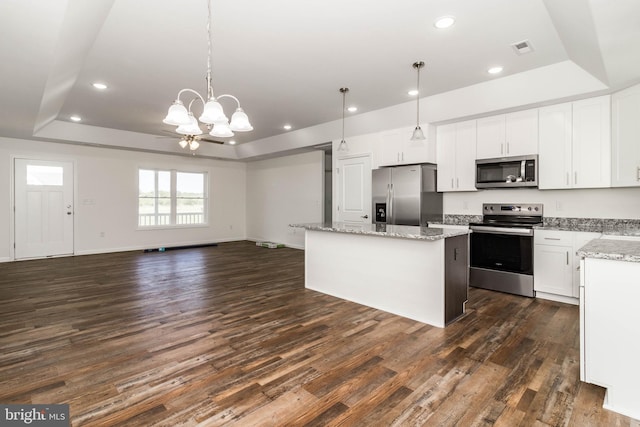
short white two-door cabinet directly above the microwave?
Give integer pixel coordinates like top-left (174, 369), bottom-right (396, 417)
top-left (476, 109), bottom-right (538, 159)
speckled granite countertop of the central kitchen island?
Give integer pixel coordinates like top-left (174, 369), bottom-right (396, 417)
top-left (289, 222), bottom-right (469, 240)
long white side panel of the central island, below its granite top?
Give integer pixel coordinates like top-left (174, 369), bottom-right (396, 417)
top-left (305, 227), bottom-right (467, 327)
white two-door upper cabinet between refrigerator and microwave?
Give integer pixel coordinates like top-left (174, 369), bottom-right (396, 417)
top-left (436, 120), bottom-right (476, 191)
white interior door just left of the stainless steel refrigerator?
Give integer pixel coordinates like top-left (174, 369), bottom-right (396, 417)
top-left (338, 155), bottom-right (371, 224)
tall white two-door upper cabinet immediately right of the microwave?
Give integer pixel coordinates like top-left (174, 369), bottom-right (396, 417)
top-left (538, 95), bottom-right (611, 189)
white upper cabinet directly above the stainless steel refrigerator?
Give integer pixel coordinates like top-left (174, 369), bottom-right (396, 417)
top-left (380, 125), bottom-right (436, 166)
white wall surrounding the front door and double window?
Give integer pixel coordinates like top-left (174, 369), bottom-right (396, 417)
top-left (0, 138), bottom-right (246, 260)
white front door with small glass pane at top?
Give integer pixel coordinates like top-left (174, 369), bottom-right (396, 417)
top-left (14, 159), bottom-right (73, 259)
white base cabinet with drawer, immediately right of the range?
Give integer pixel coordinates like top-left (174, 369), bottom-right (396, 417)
top-left (533, 230), bottom-right (600, 303)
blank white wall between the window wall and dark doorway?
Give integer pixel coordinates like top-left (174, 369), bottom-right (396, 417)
top-left (247, 151), bottom-right (324, 248)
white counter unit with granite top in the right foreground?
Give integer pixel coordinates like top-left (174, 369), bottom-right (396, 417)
top-left (578, 237), bottom-right (640, 419)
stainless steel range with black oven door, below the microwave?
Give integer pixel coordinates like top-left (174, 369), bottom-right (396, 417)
top-left (469, 203), bottom-right (542, 297)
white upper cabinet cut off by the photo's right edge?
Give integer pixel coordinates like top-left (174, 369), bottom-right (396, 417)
top-left (611, 85), bottom-right (640, 187)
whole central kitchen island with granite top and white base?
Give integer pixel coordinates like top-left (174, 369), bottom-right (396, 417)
top-left (291, 223), bottom-right (469, 327)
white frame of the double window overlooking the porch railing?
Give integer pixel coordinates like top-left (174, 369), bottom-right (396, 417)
top-left (136, 166), bottom-right (209, 230)
